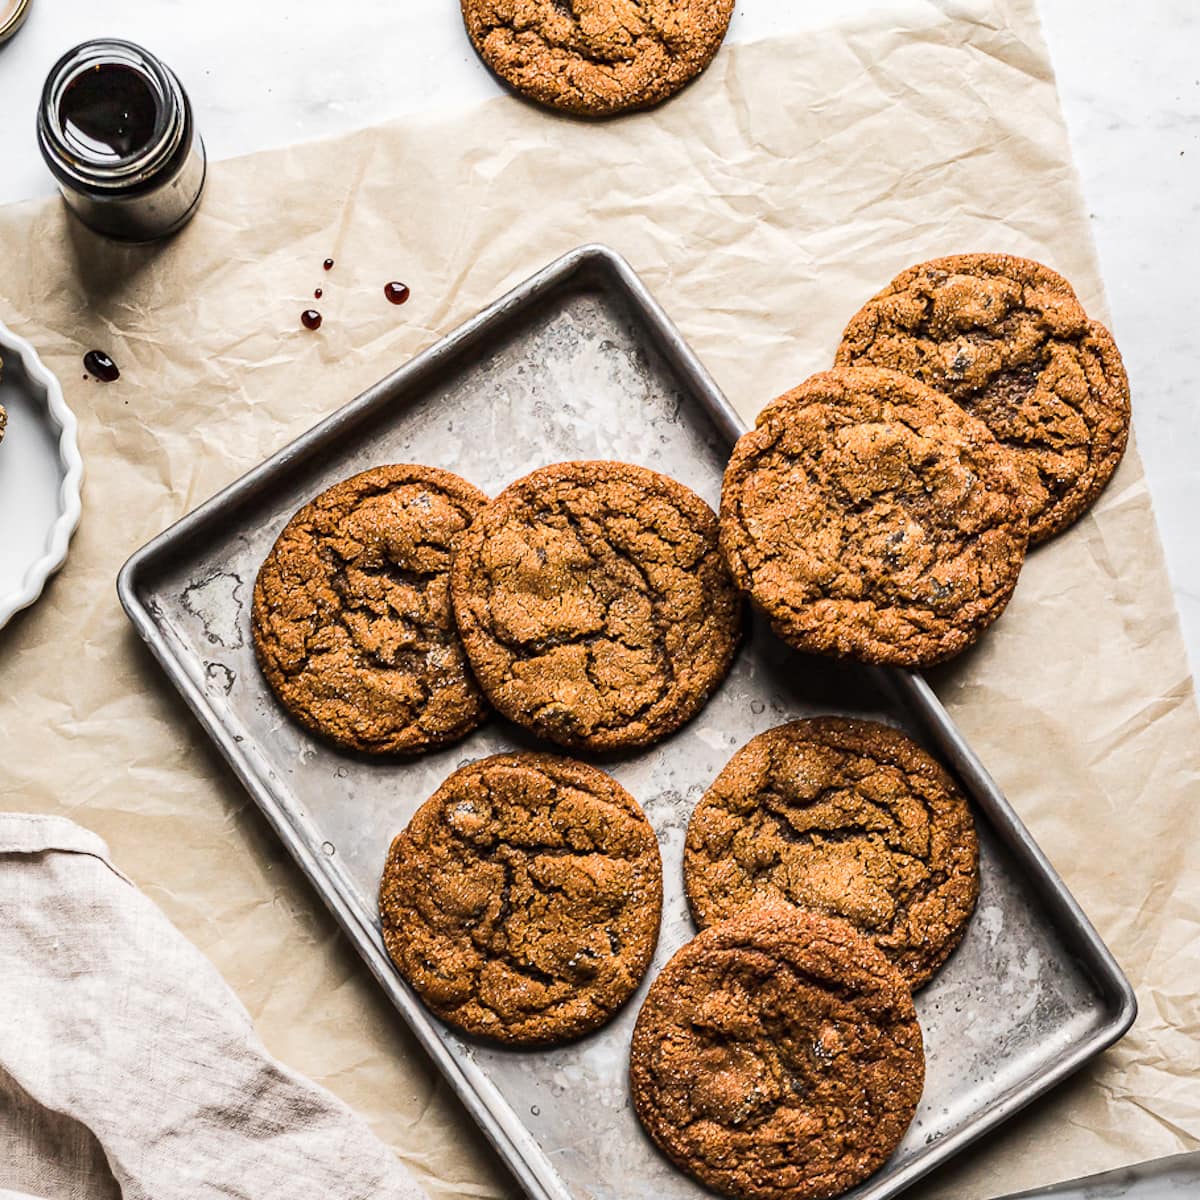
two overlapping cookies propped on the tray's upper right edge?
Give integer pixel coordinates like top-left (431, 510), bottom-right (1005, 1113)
top-left (721, 254), bottom-right (1129, 667)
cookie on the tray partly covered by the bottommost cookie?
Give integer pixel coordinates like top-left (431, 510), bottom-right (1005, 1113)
top-left (684, 716), bottom-right (979, 989)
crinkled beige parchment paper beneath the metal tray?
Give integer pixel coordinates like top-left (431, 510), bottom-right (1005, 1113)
top-left (0, 0), bottom-right (1200, 1200)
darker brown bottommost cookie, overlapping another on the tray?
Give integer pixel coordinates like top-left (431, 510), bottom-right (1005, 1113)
top-left (630, 905), bottom-right (925, 1200)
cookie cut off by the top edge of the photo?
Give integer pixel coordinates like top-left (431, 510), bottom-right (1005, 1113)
top-left (462, 0), bottom-right (733, 116)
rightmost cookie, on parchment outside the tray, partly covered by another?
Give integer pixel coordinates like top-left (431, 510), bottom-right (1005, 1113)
top-left (836, 254), bottom-right (1129, 545)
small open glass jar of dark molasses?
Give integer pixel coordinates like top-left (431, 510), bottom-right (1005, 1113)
top-left (37, 38), bottom-right (205, 241)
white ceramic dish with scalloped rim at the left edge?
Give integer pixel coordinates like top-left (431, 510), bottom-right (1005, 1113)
top-left (0, 322), bottom-right (83, 629)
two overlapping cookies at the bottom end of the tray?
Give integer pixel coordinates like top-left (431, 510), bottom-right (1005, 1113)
top-left (631, 718), bottom-right (979, 1200)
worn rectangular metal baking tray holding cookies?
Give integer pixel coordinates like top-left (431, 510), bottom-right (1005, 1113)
top-left (118, 246), bottom-right (1135, 1200)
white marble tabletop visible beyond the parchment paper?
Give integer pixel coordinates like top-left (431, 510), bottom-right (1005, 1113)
top-left (0, 0), bottom-right (1200, 667)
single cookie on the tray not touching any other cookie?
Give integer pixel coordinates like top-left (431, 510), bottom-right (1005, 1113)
top-left (379, 754), bottom-right (662, 1045)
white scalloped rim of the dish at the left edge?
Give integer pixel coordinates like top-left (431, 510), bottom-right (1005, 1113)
top-left (0, 320), bottom-right (83, 629)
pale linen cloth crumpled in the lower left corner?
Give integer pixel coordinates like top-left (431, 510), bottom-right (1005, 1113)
top-left (0, 815), bottom-right (427, 1200)
